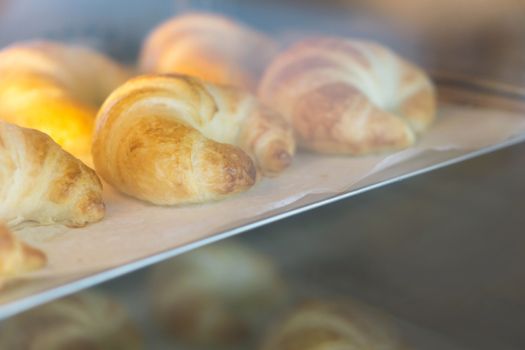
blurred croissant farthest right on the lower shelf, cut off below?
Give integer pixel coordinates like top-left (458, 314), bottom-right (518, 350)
top-left (262, 300), bottom-right (408, 350)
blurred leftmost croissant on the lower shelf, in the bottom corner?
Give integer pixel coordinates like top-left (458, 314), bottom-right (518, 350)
top-left (0, 292), bottom-right (143, 350)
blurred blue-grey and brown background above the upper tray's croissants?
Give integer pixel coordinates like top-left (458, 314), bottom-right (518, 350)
top-left (0, 0), bottom-right (525, 85)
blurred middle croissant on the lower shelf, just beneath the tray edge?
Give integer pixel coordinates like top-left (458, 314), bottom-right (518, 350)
top-left (150, 242), bottom-right (287, 349)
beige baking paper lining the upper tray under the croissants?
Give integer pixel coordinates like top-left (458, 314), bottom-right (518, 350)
top-left (8, 102), bottom-right (525, 281)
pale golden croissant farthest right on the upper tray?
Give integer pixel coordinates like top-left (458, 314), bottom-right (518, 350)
top-left (259, 37), bottom-right (435, 155)
